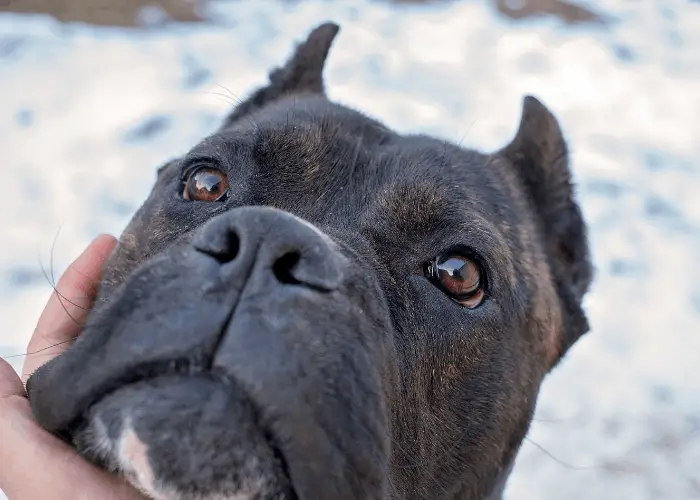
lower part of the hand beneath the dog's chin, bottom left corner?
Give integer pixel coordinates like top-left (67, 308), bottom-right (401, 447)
top-left (0, 359), bottom-right (144, 500)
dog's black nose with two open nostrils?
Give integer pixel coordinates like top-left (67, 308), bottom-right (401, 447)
top-left (192, 207), bottom-right (345, 291)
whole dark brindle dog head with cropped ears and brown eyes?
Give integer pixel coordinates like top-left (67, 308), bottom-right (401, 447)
top-left (28, 24), bottom-right (591, 500)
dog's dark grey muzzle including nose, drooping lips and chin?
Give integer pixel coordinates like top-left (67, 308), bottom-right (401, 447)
top-left (28, 207), bottom-right (392, 500)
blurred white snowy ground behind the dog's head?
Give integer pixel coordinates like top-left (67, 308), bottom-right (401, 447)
top-left (0, 0), bottom-right (700, 500)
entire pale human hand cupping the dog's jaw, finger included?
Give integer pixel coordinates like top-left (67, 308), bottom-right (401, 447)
top-left (0, 235), bottom-right (145, 500)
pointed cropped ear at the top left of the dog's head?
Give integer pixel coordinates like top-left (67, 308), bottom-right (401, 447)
top-left (221, 23), bottom-right (340, 129)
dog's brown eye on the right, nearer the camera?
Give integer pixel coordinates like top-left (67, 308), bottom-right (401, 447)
top-left (425, 254), bottom-right (486, 309)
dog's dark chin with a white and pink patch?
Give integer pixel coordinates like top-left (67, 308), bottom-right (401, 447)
top-left (71, 375), bottom-right (296, 500)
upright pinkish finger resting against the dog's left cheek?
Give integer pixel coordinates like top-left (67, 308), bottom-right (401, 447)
top-left (22, 235), bottom-right (117, 382)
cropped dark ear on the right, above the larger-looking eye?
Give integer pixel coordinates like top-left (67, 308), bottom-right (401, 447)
top-left (501, 96), bottom-right (593, 357)
